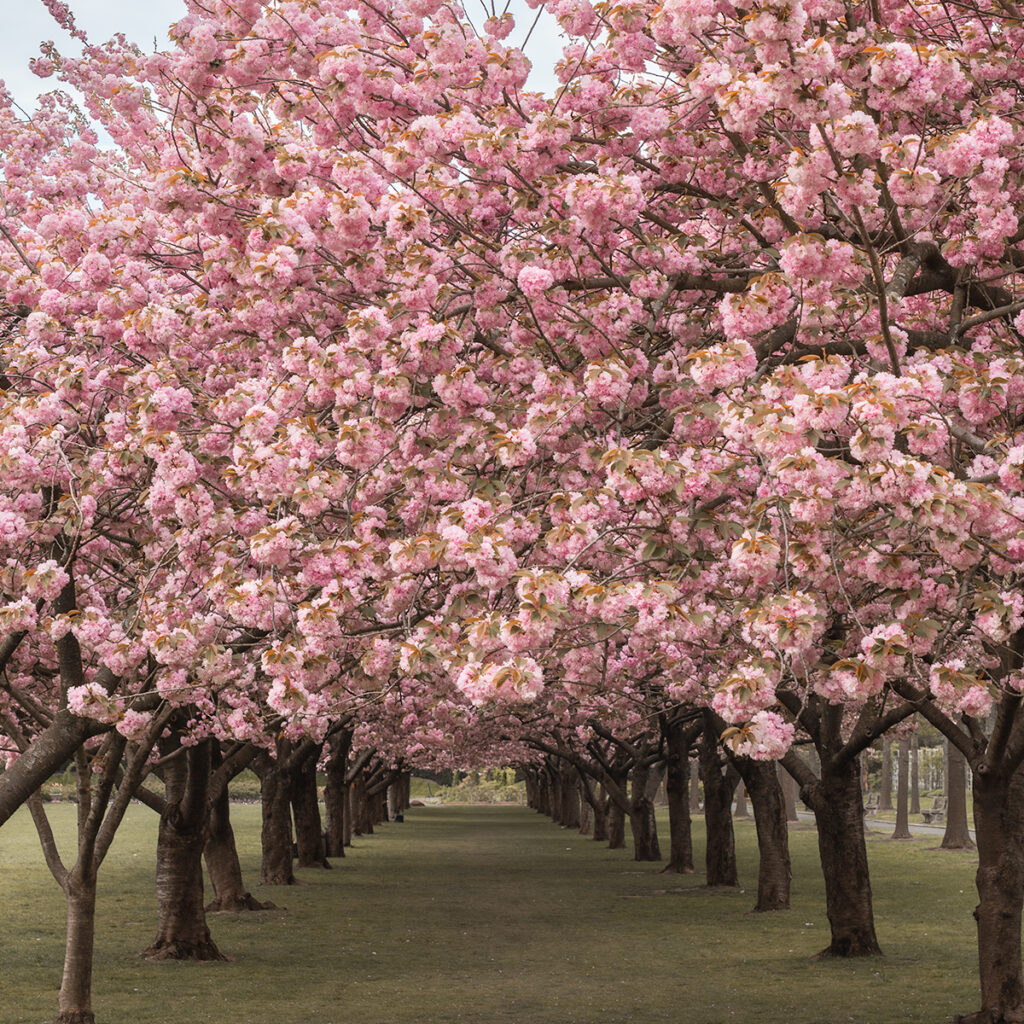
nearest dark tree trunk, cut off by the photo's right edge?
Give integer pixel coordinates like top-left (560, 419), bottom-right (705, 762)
top-left (956, 770), bottom-right (1024, 1024)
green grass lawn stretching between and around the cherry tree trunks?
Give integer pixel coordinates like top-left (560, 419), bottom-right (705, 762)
top-left (0, 805), bottom-right (978, 1024)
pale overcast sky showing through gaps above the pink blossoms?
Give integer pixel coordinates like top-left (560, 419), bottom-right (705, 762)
top-left (0, 0), bottom-right (560, 109)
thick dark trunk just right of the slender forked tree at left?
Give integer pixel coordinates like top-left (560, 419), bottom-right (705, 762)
top-left (143, 739), bottom-right (225, 961)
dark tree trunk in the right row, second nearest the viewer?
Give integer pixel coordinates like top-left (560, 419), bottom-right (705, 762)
top-left (801, 758), bottom-right (882, 957)
